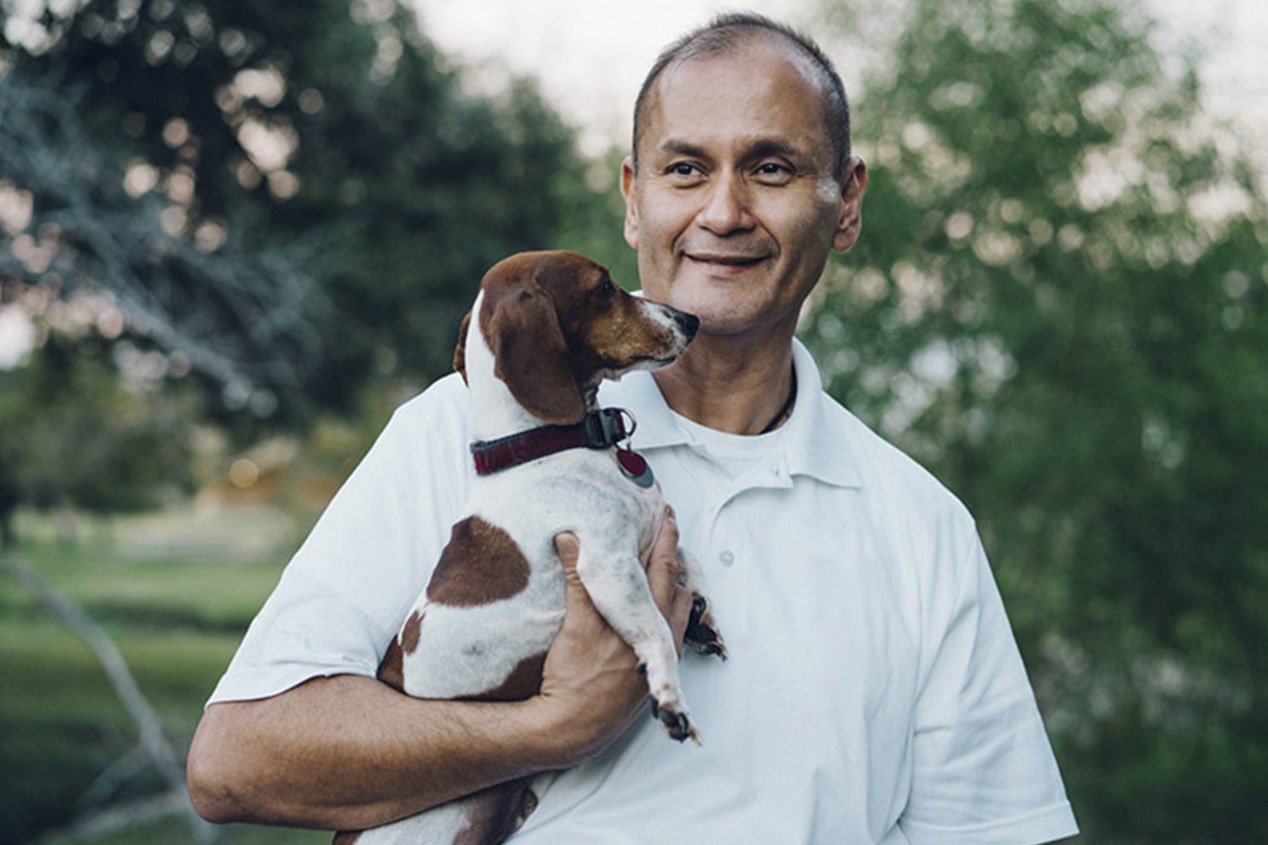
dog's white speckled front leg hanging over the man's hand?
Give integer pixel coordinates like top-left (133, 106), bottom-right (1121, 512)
top-left (577, 538), bottom-right (700, 745)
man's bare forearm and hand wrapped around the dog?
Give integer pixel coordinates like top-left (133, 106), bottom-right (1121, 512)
top-left (188, 510), bottom-right (691, 830)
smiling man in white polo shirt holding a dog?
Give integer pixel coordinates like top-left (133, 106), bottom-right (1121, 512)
top-left (190, 15), bottom-right (1077, 845)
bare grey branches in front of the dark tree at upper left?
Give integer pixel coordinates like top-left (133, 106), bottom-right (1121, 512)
top-left (0, 75), bottom-right (331, 406)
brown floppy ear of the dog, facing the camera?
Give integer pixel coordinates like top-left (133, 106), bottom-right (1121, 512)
top-left (483, 284), bottom-right (586, 425)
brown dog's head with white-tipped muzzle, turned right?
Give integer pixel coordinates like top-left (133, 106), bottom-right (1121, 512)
top-left (454, 251), bottom-right (700, 425)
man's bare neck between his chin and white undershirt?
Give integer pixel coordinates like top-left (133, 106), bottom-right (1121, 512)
top-left (653, 335), bottom-right (794, 434)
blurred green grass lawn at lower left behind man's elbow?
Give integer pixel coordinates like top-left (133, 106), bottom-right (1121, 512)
top-left (0, 502), bottom-right (330, 845)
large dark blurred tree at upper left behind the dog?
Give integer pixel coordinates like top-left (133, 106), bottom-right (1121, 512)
top-left (0, 0), bottom-right (583, 420)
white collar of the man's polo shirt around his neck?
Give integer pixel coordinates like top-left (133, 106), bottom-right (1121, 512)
top-left (598, 339), bottom-right (862, 487)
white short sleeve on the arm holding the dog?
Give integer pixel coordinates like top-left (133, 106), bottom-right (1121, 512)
top-left (210, 377), bottom-right (468, 703)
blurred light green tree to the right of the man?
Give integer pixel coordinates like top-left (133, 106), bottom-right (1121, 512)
top-left (805, 0), bottom-right (1268, 844)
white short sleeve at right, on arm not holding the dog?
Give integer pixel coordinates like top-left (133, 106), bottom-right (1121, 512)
top-left (899, 534), bottom-right (1078, 845)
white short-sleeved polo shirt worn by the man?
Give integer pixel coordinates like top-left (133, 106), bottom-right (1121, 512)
top-left (212, 344), bottom-right (1077, 845)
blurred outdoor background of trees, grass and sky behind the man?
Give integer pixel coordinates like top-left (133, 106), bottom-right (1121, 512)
top-left (0, 0), bottom-right (1268, 845)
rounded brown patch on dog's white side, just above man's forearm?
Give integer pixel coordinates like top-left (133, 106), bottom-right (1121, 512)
top-left (427, 516), bottom-right (530, 608)
